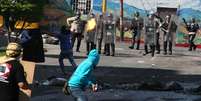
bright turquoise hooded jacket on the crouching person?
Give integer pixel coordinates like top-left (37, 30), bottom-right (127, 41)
top-left (68, 49), bottom-right (100, 89)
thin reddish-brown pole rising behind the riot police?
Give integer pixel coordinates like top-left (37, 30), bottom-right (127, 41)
top-left (120, 0), bottom-right (124, 41)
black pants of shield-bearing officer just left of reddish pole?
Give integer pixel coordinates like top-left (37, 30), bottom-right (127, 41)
top-left (105, 43), bottom-right (115, 56)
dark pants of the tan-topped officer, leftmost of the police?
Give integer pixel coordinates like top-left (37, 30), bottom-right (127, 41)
top-left (72, 33), bottom-right (82, 51)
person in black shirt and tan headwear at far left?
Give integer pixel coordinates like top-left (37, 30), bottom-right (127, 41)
top-left (0, 43), bottom-right (31, 101)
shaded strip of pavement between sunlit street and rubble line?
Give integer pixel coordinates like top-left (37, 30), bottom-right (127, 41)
top-left (34, 65), bottom-right (201, 84)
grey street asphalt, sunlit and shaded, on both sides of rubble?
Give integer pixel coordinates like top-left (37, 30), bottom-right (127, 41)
top-left (31, 42), bottom-right (201, 101)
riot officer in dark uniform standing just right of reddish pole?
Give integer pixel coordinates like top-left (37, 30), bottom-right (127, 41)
top-left (129, 12), bottom-right (143, 50)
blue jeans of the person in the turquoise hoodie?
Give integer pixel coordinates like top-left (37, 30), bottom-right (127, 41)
top-left (69, 88), bottom-right (88, 101)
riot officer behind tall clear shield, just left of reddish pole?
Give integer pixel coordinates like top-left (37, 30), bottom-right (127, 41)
top-left (104, 13), bottom-right (116, 56)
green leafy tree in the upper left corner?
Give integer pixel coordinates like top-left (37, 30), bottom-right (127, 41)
top-left (0, 0), bottom-right (46, 39)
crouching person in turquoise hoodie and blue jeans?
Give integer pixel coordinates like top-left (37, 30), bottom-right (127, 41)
top-left (68, 49), bottom-right (100, 101)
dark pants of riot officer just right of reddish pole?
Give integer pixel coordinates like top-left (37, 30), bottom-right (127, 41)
top-left (131, 30), bottom-right (141, 50)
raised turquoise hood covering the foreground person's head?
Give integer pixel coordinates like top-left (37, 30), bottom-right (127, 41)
top-left (88, 49), bottom-right (100, 66)
